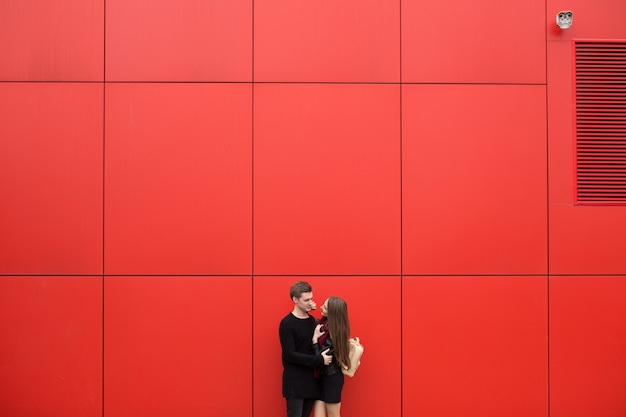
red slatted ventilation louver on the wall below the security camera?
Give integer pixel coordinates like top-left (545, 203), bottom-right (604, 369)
top-left (576, 42), bottom-right (626, 204)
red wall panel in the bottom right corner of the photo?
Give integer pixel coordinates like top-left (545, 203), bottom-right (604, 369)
top-left (550, 276), bottom-right (626, 417)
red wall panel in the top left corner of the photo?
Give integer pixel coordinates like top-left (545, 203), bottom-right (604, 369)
top-left (0, 0), bottom-right (104, 81)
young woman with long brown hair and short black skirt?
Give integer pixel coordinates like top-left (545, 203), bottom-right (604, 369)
top-left (313, 297), bottom-right (350, 417)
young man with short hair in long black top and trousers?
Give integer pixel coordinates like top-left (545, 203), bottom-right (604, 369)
top-left (278, 281), bottom-right (332, 417)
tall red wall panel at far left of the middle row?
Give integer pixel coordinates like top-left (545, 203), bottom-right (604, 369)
top-left (0, 83), bottom-right (103, 274)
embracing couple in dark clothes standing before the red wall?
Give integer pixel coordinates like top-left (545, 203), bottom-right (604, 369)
top-left (279, 281), bottom-right (350, 417)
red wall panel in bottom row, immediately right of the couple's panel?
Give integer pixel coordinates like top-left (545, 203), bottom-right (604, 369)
top-left (402, 276), bottom-right (548, 417)
